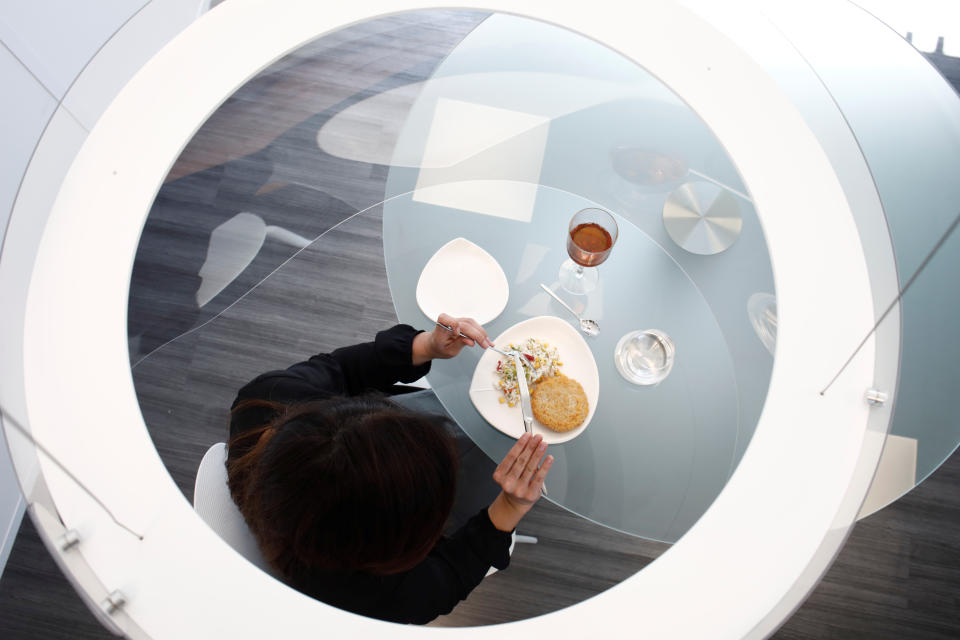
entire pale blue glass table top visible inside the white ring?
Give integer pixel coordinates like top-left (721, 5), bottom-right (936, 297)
top-left (383, 15), bottom-right (776, 542)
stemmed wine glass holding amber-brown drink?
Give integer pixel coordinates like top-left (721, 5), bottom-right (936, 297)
top-left (559, 207), bottom-right (619, 295)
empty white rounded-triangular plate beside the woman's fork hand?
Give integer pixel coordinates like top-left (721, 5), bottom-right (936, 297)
top-left (417, 238), bottom-right (510, 324)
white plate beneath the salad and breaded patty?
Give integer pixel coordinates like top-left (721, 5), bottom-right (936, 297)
top-left (470, 316), bottom-right (600, 444)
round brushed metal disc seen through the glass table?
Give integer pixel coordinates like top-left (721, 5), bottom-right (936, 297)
top-left (663, 182), bottom-right (743, 256)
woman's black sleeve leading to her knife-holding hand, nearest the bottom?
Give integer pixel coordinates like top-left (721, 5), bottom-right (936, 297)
top-left (386, 508), bottom-right (512, 624)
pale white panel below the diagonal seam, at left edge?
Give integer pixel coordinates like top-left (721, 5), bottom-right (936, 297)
top-left (0, 47), bottom-right (57, 242)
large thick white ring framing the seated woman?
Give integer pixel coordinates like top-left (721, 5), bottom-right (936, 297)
top-left (3, 0), bottom-right (888, 638)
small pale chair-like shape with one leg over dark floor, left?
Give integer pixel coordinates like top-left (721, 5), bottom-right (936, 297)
top-left (197, 212), bottom-right (310, 307)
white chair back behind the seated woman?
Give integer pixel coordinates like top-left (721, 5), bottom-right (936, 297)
top-left (193, 442), bottom-right (273, 573)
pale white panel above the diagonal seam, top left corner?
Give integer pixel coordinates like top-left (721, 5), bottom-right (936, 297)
top-left (0, 0), bottom-right (148, 98)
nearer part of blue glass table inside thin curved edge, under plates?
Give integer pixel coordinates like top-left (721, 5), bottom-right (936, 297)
top-left (383, 181), bottom-right (769, 542)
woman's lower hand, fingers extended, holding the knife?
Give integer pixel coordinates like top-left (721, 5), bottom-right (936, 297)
top-left (487, 433), bottom-right (553, 531)
